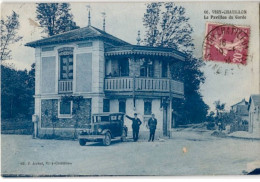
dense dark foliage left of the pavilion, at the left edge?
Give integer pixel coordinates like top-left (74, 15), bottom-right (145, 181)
top-left (1, 64), bottom-right (35, 119)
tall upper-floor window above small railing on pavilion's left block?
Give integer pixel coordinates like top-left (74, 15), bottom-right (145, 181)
top-left (58, 47), bottom-right (73, 80)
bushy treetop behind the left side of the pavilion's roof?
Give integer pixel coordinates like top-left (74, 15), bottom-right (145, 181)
top-left (36, 3), bottom-right (79, 36)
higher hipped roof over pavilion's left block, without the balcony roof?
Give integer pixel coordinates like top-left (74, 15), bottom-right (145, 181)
top-left (25, 26), bottom-right (130, 47)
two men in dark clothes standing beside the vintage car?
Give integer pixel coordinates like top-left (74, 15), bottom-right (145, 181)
top-left (126, 113), bottom-right (157, 142)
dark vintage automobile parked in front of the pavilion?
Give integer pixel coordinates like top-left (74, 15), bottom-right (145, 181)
top-left (78, 113), bottom-right (127, 146)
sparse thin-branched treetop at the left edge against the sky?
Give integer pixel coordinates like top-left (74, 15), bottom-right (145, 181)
top-left (0, 11), bottom-right (22, 61)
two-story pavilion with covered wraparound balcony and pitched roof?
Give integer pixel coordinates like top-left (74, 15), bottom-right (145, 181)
top-left (26, 25), bottom-right (185, 137)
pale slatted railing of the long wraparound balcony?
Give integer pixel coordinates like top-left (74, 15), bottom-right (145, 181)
top-left (104, 77), bottom-right (184, 94)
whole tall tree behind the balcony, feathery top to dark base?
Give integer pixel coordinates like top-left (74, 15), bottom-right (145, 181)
top-left (143, 2), bottom-right (209, 123)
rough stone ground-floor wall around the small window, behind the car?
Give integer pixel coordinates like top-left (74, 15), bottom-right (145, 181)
top-left (41, 99), bottom-right (91, 128)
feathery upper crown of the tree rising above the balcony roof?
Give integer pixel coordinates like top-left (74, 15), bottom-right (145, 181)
top-left (143, 2), bottom-right (194, 54)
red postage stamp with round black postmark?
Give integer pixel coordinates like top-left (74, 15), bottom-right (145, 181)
top-left (203, 23), bottom-right (250, 65)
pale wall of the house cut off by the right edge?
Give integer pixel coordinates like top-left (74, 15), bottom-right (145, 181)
top-left (248, 94), bottom-right (260, 136)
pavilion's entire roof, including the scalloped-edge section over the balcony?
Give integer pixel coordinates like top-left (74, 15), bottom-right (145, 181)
top-left (25, 26), bottom-right (186, 60)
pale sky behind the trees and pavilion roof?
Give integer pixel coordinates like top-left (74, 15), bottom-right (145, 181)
top-left (1, 2), bottom-right (259, 110)
